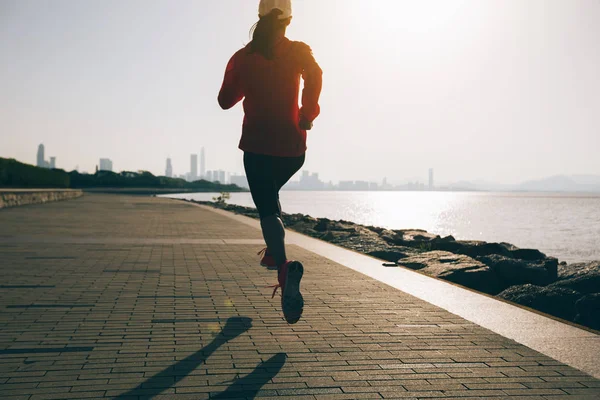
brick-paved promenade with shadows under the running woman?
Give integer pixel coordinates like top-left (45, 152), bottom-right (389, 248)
top-left (0, 195), bottom-right (600, 400)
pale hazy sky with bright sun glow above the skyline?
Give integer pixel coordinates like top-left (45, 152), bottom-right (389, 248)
top-left (0, 0), bottom-right (600, 182)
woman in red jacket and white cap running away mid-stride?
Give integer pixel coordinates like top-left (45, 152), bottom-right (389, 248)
top-left (219, 0), bottom-right (322, 324)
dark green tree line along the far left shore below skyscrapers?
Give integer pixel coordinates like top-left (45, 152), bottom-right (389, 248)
top-left (0, 158), bottom-right (244, 193)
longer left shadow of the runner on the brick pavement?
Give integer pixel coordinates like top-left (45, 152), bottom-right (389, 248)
top-left (116, 317), bottom-right (252, 399)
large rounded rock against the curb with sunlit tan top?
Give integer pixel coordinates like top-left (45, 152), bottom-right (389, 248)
top-left (399, 251), bottom-right (502, 294)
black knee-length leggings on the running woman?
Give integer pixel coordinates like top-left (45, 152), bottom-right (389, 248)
top-left (244, 153), bottom-right (305, 219)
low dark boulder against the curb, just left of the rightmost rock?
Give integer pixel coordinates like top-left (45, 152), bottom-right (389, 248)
top-left (498, 284), bottom-right (581, 321)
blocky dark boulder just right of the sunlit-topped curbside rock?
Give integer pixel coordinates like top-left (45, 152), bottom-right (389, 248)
top-left (477, 254), bottom-right (558, 287)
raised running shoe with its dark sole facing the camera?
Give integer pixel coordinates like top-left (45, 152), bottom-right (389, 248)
top-left (270, 261), bottom-right (304, 324)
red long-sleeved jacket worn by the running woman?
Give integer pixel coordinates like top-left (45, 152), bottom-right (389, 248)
top-left (219, 38), bottom-right (322, 157)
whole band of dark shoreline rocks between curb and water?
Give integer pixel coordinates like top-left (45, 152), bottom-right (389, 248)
top-left (193, 201), bottom-right (600, 330)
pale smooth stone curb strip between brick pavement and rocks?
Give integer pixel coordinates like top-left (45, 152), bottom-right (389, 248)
top-left (190, 203), bottom-right (600, 379)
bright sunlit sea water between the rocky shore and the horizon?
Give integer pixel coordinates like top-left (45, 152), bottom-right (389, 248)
top-left (166, 192), bottom-right (600, 262)
